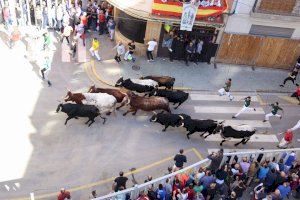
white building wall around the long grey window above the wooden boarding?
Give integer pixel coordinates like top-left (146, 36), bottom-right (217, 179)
top-left (225, 0), bottom-right (300, 39)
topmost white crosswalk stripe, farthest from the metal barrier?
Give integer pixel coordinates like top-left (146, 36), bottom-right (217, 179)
top-left (190, 93), bottom-right (258, 103)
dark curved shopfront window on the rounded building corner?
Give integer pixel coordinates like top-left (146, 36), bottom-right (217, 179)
top-left (117, 11), bottom-right (147, 43)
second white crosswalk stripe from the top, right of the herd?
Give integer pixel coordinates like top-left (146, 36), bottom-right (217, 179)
top-left (194, 106), bottom-right (265, 114)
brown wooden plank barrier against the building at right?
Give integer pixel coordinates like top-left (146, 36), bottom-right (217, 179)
top-left (216, 33), bottom-right (300, 69)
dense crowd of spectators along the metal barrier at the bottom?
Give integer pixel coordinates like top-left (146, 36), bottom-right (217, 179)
top-left (77, 149), bottom-right (300, 200)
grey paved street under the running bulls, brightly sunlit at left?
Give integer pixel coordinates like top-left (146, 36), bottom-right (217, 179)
top-left (0, 28), bottom-right (300, 199)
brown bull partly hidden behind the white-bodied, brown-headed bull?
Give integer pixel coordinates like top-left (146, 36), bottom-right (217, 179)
top-left (88, 85), bottom-right (128, 110)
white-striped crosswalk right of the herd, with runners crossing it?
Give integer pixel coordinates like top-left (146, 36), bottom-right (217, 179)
top-left (190, 92), bottom-right (278, 143)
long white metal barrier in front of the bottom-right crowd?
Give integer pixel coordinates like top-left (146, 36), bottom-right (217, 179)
top-left (93, 148), bottom-right (300, 200)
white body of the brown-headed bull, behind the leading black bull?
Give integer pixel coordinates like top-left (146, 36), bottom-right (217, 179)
top-left (82, 93), bottom-right (117, 114)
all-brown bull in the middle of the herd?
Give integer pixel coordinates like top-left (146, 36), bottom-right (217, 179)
top-left (123, 91), bottom-right (171, 116)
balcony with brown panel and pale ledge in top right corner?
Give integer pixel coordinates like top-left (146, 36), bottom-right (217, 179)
top-left (251, 0), bottom-right (300, 21)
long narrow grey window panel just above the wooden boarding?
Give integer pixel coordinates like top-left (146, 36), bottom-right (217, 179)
top-left (249, 25), bottom-right (295, 38)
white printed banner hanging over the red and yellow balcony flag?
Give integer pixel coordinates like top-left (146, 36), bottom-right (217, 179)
top-left (180, 3), bottom-right (198, 31)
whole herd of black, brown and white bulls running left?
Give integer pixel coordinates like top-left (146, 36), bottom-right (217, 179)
top-left (56, 76), bottom-right (256, 145)
